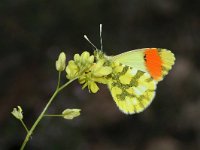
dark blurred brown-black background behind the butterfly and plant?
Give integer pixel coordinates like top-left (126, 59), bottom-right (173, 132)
top-left (0, 0), bottom-right (200, 150)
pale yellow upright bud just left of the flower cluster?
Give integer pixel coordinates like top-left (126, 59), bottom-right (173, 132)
top-left (56, 52), bottom-right (66, 71)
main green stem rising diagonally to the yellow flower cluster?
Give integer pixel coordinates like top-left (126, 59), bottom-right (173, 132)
top-left (20, 78), bottom-right (77, 150)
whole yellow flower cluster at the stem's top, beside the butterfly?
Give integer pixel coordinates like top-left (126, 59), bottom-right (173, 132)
top-left (66, 51), bottom-right (112, 93)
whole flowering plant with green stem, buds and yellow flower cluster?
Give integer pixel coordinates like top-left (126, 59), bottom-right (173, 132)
top-left (11, 47), bottom-right (112, 150)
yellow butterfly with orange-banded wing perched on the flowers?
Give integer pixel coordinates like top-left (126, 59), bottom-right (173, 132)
top-left (94, 48), bottom-right (175, 114)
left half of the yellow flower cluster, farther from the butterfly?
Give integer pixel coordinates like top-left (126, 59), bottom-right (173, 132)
top-left (66, 51), bottom-right (94, 80)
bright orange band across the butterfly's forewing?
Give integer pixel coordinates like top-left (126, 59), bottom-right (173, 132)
top-left (144, 48), bottom-right (163, 81)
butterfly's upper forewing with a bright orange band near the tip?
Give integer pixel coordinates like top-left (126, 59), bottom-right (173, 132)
top-left (107, 48), bottom-right (175, 81)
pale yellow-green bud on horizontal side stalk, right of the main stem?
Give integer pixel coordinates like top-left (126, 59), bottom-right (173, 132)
top-left (62, 109), bottom-right (81, 119)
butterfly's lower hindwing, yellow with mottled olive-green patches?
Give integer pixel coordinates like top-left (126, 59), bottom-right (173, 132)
top-left (108, 63), bottom-right (157, 114)
